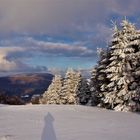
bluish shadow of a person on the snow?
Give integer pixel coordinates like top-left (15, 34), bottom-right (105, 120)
top-left (41, 112), bottom-right (57, 140)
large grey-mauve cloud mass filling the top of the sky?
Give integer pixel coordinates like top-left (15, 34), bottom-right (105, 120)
top-left (0, 0), bottom-right (140, 36)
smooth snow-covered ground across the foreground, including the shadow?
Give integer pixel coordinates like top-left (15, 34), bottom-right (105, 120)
top-left (0, 105), bottom-right (140, 140)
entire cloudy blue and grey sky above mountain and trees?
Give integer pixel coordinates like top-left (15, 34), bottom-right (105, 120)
top-left (0, 0), bottom-right (140, 73)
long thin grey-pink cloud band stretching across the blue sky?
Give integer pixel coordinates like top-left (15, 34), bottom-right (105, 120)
top-left (0, 37), bottom-right (95, 59)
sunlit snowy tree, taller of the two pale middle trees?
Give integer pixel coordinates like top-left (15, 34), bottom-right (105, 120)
top-left (60, 68), bottom-right (80, 104)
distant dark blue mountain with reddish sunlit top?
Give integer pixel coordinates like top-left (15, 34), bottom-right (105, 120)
top-left (0, 73), bottom-right (53, 100)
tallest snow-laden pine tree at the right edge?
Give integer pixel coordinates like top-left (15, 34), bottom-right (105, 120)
top-left (99, 20), bottom-right (140, 111)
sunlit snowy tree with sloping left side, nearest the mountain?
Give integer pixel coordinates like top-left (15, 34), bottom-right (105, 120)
top-left (40, 75), bottom-right (62, 104)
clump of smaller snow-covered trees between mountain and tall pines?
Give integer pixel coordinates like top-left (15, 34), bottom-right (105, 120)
top-left (40, 69), bottom-right (91, 105)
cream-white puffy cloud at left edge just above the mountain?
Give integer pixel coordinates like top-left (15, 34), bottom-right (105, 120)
top-left (0, 46), bottom-right (47, 73)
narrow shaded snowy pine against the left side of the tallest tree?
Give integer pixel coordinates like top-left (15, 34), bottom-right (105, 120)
top-left (90, 48), bottom-right (110, 105)
